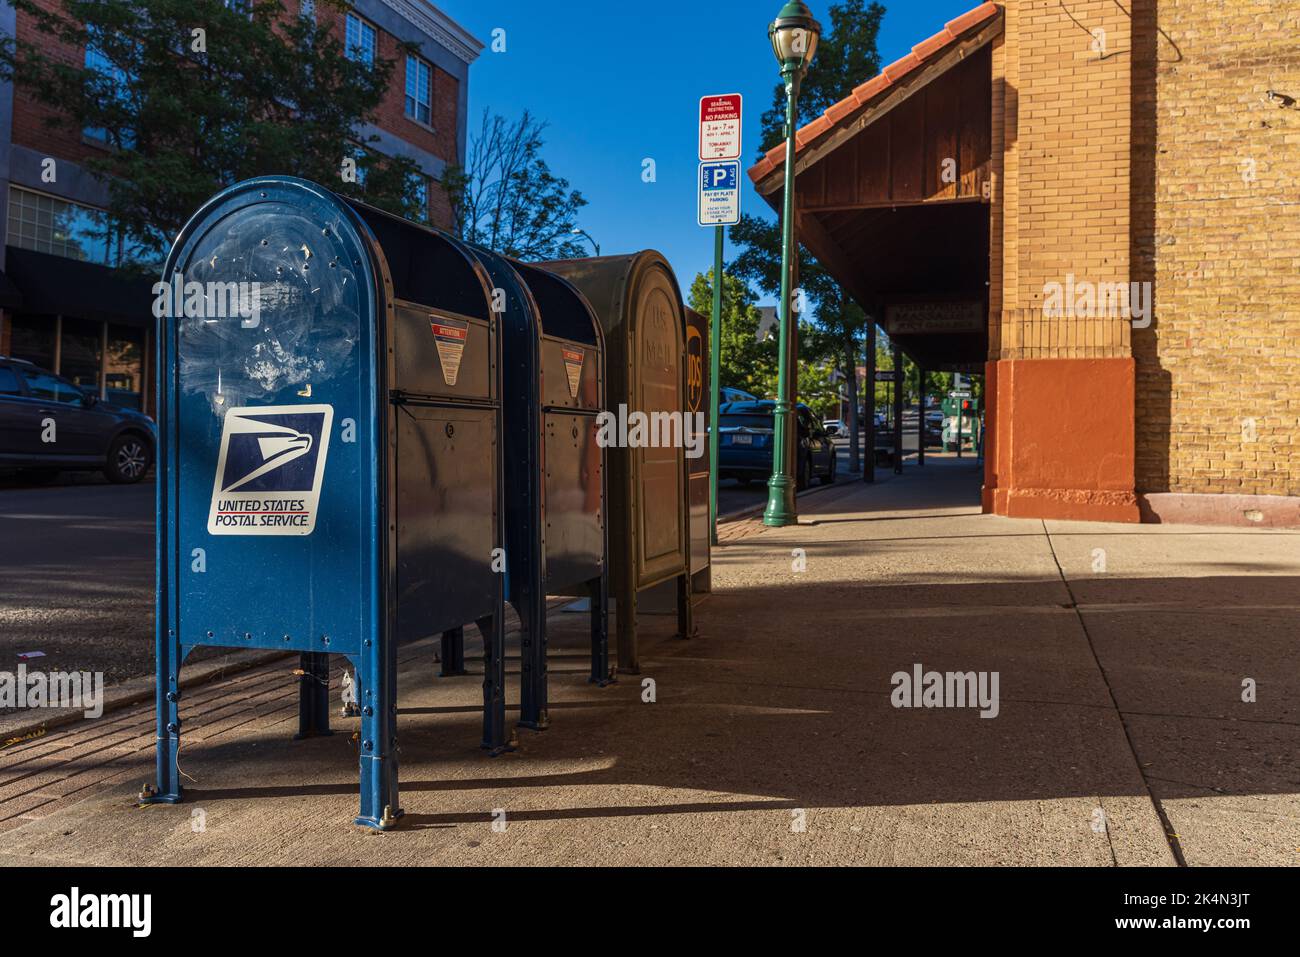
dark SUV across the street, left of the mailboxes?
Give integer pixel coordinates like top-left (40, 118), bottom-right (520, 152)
top-left (0, 356), bottom-right (157, 482)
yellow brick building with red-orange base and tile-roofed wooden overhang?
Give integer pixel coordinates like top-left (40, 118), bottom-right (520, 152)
top-left (750, 0), bottom-right (1300, 525)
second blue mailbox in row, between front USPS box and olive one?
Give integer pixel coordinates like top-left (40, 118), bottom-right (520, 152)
top-left (443, 246), bottom-right (611, 731)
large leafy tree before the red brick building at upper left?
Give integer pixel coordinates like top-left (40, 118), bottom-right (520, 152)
top-left (0, 0), bottom-right (423, 263)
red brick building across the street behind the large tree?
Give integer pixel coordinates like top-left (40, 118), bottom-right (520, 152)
top-left (0, 0), bottom-right (482, 410)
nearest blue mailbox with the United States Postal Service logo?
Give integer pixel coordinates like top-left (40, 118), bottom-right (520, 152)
top-left (142, 177), bottom-right (506, 828)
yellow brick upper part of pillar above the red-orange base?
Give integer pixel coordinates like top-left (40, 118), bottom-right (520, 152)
top-left (991, 0), bottom-right (1131, 359)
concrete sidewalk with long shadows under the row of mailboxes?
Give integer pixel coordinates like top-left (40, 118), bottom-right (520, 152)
top-left (0, 456), bottom-right (1300, 866)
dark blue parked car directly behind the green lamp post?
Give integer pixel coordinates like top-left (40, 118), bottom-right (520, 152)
top-left (718, 399), bottom-right (835, 489)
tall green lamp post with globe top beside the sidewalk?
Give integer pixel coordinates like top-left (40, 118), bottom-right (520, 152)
top-left (763, 0), bottom-right (822, 525)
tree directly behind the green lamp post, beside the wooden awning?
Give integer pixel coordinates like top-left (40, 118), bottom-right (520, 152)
top-left (731, 0), bottom-right (885, 471)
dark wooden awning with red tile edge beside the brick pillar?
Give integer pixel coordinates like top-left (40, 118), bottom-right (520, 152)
top-left (749, 3), bottom-right (1004, 368)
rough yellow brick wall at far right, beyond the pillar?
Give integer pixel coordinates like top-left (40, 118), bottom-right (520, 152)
top-left (1132, 0), bottom-right (1300, 495)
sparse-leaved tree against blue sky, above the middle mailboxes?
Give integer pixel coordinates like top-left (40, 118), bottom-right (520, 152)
top-left (442, 109), bottom-right (586, 261)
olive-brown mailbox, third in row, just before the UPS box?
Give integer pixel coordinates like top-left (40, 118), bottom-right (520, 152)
top-left (541, 251), bottom-right (694, 674)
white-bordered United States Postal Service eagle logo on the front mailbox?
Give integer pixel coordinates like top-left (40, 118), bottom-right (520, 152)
top-left (208, 406), bottom-right (334, 534)
